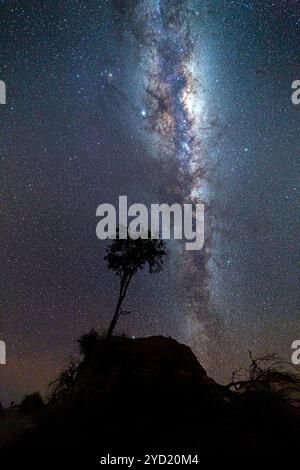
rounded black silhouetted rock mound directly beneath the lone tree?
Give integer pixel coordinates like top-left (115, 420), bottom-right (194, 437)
top-left (32, 336), bottom-right (228, 450)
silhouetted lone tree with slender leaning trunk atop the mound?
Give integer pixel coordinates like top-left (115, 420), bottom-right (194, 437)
top-left (104, 233), bottom-right (166, 338)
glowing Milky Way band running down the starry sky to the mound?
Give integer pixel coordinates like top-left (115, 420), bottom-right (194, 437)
top-left (134, 0), bottom-right (216, 360)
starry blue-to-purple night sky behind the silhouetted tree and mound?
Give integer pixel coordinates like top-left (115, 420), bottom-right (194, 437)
top-left (0, 0), bottom-right (300, 403)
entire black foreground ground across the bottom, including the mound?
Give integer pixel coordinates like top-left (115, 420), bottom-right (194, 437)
top-left (0, 336), bottom-right (300, 465)
